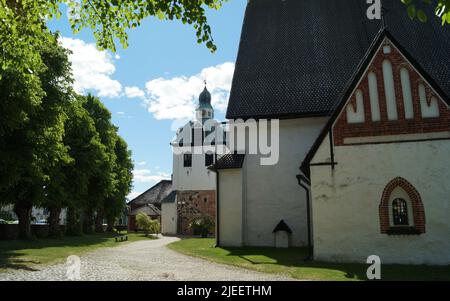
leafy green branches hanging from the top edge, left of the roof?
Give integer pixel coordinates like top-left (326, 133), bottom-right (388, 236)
top-left (64, 0), bottom-right (226, 52)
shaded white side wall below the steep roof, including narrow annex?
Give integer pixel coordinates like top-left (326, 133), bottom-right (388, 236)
top-left (219, 118), bottom-right (327, 247)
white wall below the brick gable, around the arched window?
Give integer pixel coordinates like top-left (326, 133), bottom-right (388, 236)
top-left (311, 139), bottom-right (450, 264)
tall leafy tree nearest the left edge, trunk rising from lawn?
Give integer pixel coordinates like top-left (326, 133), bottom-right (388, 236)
top-left (0, 34), bottom-right (72, 238)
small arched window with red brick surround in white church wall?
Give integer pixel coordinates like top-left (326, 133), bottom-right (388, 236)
top-left (379, 177), bottom-right (425, 235)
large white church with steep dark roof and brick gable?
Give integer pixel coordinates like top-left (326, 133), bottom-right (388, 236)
top-left (214, 0), bottom-right (450, 265)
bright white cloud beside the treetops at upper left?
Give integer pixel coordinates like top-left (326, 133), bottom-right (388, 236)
top-left (61, 37), bottom-right (122, 97)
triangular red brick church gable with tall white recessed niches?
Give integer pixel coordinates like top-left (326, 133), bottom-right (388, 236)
top-left (333, 38), bottom-right (450, 146)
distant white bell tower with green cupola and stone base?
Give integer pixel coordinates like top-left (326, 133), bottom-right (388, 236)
top-left (161, 87), bottom-right (224, 234)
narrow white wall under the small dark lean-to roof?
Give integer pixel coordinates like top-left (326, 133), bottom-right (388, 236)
top-left (218, 169), bottom-right (243, 247)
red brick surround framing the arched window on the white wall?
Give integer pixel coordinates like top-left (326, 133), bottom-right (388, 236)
top-left (379, 177), bottom-right (425, 234)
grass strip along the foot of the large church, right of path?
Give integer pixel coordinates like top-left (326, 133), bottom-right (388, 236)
top-left (169, 239), bottom-right (450, 281)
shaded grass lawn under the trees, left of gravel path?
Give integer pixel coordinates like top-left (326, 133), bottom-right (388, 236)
top-left (0, 233), bottom-right (155, 272)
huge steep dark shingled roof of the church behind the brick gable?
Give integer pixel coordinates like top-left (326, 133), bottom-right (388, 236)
top-left (227, 0), bottom-right (450, 119)
